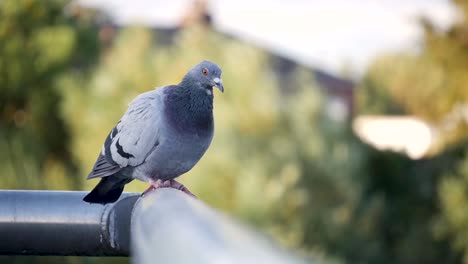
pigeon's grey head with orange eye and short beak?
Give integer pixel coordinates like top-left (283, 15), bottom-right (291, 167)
top-left (184, 60), bottom-right (224, 92)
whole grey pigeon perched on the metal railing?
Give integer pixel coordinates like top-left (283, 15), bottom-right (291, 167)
top-left (83, 60), bottom-right (224, 204)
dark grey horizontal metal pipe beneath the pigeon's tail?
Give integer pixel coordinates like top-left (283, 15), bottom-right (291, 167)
top-left (0, 191), bottom-right (139, 256)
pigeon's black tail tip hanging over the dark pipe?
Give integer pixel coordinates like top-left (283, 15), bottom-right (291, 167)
top-left (83, 175), bottom-right (131, 204)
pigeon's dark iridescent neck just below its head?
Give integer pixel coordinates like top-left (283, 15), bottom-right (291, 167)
top-left (164, 82), bottom-right (213, 134)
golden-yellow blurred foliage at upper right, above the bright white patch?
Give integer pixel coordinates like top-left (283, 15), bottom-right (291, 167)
top-left (358, 0), bottom-right (468, 153)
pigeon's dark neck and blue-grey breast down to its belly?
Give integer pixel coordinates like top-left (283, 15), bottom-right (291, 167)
top-left (134, 86), bottom-right (214, 180)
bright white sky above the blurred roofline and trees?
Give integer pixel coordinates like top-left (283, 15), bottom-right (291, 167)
top-left (77, 0), bottom-right (457, 76)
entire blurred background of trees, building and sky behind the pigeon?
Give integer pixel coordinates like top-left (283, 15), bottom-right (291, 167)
top-left (0, 0), bottom-right (468, 263)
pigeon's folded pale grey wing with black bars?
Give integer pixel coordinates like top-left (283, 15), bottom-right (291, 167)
top-left (88, 89), bottom-right (163, 179)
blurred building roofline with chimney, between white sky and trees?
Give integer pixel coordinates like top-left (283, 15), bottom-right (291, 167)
top-left (76, 0), bottom-right (355, 121)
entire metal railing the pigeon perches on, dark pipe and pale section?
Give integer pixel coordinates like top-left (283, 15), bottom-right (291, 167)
top-left (0, 188), bottom-right (305, 264)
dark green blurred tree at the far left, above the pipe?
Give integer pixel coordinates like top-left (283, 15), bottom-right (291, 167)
top-left (0, 0), bottom-right (98, 189)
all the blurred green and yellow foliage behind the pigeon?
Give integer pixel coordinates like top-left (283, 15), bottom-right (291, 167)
top-left (0, 0), bottom-right (468, 263)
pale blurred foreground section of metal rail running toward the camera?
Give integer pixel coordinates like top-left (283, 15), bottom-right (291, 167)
top-left (131, 188), bottom-right (310, 264)
